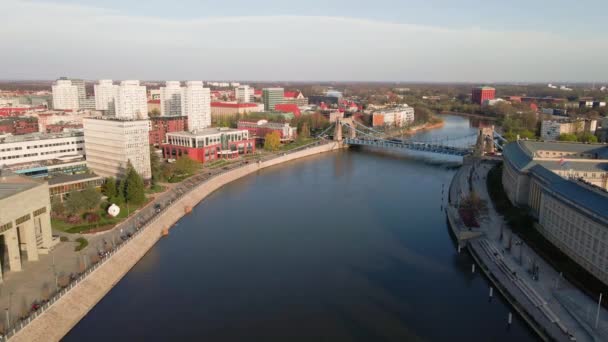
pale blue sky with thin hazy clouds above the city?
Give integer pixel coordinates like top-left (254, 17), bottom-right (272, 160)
top-left (0, 0), bottom-right (608, 83)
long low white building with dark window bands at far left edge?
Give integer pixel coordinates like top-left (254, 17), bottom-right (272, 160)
top-left (0, 130), bottom-right (85, 165)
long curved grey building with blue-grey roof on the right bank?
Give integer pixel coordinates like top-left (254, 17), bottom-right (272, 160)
top-left (502, 140), bottom-right (608, 284)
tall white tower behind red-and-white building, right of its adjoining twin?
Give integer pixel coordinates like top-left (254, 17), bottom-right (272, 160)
top-left (182, 81), bottom-right (211, 131)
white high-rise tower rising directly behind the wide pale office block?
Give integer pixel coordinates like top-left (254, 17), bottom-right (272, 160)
top-left (114, 81), bottom-right (148, 120)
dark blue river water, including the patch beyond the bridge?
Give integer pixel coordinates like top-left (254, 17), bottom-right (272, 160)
top-left (65, 116), bottom-right (536, 341)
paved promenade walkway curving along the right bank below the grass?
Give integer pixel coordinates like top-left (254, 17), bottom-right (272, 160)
top-left (451, 162), bottom-right (608, 341)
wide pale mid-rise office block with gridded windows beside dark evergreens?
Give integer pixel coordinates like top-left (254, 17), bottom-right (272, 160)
top-left (83, 117), bottom-right (152, 179)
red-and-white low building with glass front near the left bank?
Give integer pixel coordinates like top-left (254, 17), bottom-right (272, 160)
top-left (162, 128), bottom-right (255, 163)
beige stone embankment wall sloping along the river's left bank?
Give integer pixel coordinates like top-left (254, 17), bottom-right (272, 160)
top-left (10, 142), bottom-right (344, 342)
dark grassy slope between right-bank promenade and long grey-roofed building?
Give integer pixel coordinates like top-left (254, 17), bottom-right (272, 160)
top-left (487, 164), bottom-right (608, 297)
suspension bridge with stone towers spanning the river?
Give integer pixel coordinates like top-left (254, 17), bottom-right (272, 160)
top-left (317, 118), bottom-right (506, 157)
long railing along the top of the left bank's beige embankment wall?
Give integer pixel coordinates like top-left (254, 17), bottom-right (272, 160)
top-left (0, 139), bottom-right (333, 341)
